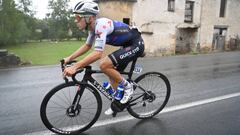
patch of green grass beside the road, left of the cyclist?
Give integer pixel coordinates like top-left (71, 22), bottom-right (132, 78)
top-left (1, 41), bottom-right (91, 65)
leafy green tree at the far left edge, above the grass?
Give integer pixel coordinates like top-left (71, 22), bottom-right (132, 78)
top-left (0, 0), bottom-right (30, 45)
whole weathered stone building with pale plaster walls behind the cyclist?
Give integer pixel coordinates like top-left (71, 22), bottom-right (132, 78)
top-left (99, 0), bottom-right (240, 56)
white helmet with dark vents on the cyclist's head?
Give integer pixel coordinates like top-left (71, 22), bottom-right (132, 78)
top-left (73, 0), bottom-right (99, 16)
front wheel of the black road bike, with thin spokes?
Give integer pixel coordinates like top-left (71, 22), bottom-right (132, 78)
top-left (40, 82), bottom-right (102, 135)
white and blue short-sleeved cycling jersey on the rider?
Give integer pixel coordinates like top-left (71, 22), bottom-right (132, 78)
top-left (86, 18), bottom-right (138, 51)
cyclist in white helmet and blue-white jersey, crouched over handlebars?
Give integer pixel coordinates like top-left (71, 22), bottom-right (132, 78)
top-left (63, 0), bottom-right (144, 115)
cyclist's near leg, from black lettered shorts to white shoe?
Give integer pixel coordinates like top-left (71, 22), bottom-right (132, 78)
top-left (100, 37), bottom-right (144, 104)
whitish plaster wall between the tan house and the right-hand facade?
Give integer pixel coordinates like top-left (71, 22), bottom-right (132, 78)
top-left (133, 0), bottom-right (201, 56)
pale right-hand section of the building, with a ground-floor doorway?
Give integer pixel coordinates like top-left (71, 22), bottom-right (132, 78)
top-left (199, 0), bottom-right (240, 51)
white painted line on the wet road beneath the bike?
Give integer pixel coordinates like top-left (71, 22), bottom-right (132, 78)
top-left (25, 92), bottom-right (240, 135)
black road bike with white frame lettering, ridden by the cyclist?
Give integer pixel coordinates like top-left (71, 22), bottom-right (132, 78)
top-left (40, 55), bottom-right (171, 135)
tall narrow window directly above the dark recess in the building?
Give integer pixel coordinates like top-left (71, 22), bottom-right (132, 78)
top-left (184, 1), bottom-right (194, 22)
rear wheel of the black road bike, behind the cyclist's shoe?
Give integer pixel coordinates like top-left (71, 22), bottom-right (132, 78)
top-left (127, 72), bottom-right (171, 119)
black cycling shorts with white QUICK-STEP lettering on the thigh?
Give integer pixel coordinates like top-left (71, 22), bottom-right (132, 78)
top-left (108, 36), bottom-right (144, 71)
